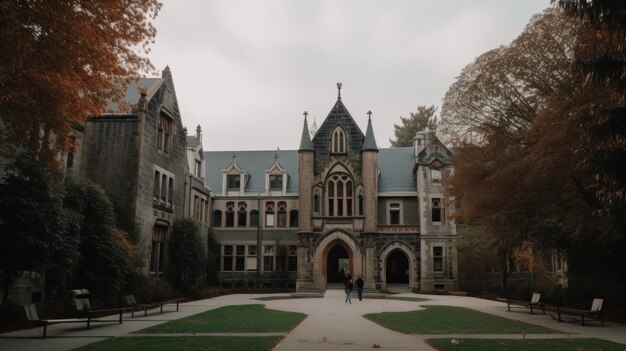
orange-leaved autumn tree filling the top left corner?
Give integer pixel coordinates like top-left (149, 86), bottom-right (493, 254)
top-left (0, 0), bottom-right (161, 168)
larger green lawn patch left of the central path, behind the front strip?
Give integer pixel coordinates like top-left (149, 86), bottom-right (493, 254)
top-left (139, 305), bottom-right (306, 333)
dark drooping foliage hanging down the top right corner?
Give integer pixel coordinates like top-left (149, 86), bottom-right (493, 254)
top-left (553, 0), bottom-right (626, 217)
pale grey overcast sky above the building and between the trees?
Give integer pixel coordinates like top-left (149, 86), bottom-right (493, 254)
top-left (150, 0), bottom-right (550, 151)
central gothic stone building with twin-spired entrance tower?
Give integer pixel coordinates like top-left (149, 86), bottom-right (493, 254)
top-left (205, 86), bottom-right (458, 291)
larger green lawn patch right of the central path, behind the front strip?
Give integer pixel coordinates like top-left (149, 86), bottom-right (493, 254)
top-left (365, 306), bottom-right (556, 334)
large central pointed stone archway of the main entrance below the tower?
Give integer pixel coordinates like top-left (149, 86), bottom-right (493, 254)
top-left (313, 231), bottom-right (363, 287)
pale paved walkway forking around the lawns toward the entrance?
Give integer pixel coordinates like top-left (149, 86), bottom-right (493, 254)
top-left (0, 290), bottom-right (626, 351)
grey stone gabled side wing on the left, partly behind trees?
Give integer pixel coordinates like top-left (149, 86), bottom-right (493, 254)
top-left (80, 67), bottom-right (209, 277)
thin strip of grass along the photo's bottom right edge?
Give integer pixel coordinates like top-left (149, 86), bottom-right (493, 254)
top-left (426, 338), bottom-right (626, 351)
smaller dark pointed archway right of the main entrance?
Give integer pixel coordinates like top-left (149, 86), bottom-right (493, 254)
top-left (380, 241), bottom-right (419, 289)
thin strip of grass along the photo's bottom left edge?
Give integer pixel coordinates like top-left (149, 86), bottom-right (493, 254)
top-left (76, 336), bottom-right (282, 351)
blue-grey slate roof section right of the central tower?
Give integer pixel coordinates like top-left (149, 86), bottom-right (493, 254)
top-left (378, 147), bottom-right (417, 193)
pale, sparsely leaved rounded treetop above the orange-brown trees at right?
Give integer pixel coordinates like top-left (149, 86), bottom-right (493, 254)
top-left (439, 10), bottom-right (577, 143)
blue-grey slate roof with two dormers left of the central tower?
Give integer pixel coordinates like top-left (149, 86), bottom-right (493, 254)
top-left (204, 150), bottom-right (299, 195)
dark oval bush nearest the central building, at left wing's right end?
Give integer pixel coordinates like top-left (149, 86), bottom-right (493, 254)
top-left (167, 218), bottom-right (207, 293)
